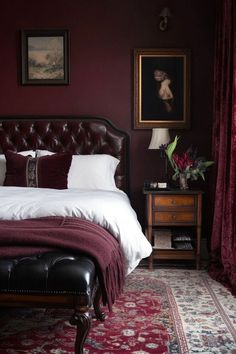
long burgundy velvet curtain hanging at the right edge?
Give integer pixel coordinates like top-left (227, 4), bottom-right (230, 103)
top-left (210, 0), bottom-right (236, 294)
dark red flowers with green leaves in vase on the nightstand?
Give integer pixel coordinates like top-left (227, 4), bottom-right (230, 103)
top-left (164, 136), bottom-right (214, 180)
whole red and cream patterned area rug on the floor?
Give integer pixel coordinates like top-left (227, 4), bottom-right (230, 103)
top-left (0, 269), bottom-right (236, 354)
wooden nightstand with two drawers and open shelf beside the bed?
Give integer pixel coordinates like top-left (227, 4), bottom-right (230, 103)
top-left (143, 189), bottom-right (203, 269)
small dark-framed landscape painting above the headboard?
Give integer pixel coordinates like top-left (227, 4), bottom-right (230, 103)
top-left (21, 30), bottom-right (69, 85)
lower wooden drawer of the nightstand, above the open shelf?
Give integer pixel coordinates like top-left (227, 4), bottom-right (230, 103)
top-left (153, 211), bottom-right (196, 225)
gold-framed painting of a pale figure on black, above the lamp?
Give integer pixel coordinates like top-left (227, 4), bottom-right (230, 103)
top-left (134, 49), bottom-right (190, 129)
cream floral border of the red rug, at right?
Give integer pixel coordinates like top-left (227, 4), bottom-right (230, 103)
top-left (137, 269), bottom-right (236, 354)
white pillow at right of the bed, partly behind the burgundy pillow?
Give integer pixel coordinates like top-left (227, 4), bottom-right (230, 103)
top-left (36, 150), bottom-right (120, 190)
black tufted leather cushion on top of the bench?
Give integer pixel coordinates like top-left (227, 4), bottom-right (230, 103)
top-left (0, 252), bottom-right (96, 303)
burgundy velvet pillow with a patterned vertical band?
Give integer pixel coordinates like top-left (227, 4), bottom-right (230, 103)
top-left (4, 151), bottom-right (72, 189)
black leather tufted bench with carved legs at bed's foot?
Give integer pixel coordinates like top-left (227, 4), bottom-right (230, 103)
top-left (0, 252), bottom-right (105, 354)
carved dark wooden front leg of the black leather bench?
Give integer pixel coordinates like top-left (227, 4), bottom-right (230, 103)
top-left (70, 310), bottom-right (91, 354)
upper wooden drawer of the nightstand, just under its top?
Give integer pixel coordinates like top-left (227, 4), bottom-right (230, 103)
top-left (152, 195), bottom-right (196, 210)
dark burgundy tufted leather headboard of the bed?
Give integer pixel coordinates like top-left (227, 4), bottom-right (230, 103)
top-left (0, 116), bottom-right (129, 193)
